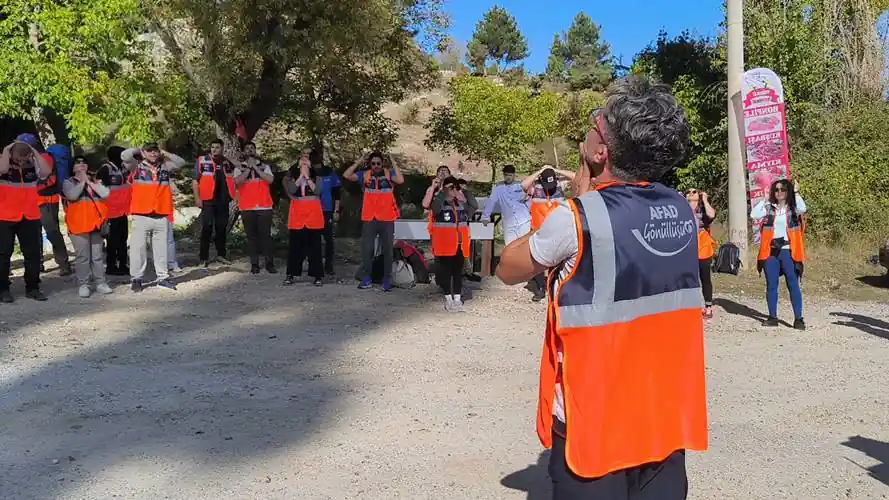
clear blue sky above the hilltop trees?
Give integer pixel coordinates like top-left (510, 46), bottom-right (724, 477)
top-left (445, 0), bottom-right (724, 73)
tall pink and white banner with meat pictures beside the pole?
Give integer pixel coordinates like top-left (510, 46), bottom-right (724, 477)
top-left (741, 68), bottom-right (790, 243)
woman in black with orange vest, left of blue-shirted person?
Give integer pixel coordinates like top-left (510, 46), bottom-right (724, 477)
top-left (283, 154), bottom-right (324, 286)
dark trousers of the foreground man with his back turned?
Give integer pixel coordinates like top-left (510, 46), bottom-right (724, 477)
top-left (549, 432), bottom-right (688, 500)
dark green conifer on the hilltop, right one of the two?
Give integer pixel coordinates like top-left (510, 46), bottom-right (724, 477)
top-left (546, 12), bottom-right (614, 90)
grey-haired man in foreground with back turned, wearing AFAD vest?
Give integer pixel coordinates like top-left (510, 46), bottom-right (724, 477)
top-left (497, 77), bottom-right (707, 500)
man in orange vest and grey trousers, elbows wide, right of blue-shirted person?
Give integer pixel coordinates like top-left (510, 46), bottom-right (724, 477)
top-left (343, 152), bottom-right (404, 292)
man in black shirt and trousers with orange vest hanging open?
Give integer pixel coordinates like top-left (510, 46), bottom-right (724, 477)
top-left (192, 139), bottom-right (239, 267)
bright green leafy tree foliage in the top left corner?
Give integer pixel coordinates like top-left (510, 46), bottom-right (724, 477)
top-left (0, 0), bottom-right (176, 143)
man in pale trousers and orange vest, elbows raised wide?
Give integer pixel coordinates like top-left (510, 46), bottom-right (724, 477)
top-left (120, 142), bottom-right (186, 293)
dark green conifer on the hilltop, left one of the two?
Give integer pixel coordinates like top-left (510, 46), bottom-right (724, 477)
top-left (467, 5), bottom-right (529, 74)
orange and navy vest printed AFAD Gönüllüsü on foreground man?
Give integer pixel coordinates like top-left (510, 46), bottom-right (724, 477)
top-left (537, 183), bottom-right (707, 478)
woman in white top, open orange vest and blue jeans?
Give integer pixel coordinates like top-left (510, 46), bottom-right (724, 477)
top-left (750, 179), bottom-right (806, 330)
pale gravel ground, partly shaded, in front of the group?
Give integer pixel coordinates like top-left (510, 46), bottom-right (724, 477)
top-left (0, 265), bottom-right (889, 500)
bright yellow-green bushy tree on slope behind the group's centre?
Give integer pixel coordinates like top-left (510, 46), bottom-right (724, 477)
top-left (426, 76), bottom-right (561, 182)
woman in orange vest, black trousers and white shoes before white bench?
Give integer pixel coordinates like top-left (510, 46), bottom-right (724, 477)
top-left (424, 176), bottom-right (478, 312)
